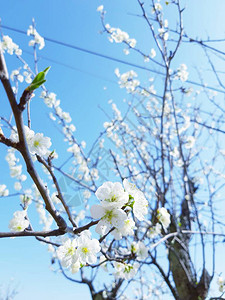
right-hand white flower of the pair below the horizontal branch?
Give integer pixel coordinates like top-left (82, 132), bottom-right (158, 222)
top-left (77, 230), bottom-right (101, 264)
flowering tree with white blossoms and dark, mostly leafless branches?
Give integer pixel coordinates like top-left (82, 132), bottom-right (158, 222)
top-left (0, 0), bottom-right (225, 300)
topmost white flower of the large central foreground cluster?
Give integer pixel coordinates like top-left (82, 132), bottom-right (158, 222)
top-left (95, 181), bottom-right (129, 208)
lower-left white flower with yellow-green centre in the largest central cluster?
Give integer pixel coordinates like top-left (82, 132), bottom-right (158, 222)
top-left (91, 205), bottom-right (127, 235)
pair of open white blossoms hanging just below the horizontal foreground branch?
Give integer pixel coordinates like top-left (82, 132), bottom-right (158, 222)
top-left (57, 230), bottom-right (101, 273)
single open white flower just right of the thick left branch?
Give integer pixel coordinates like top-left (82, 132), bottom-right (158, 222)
top-left (29, 133), bottom-right (52, 156)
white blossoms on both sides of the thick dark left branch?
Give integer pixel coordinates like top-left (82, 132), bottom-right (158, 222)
top-left (10, 126), bottom-right (52, 156)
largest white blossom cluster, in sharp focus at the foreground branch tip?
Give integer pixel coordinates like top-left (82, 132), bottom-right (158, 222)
top-left (91, 179), bottom-right (148, 238)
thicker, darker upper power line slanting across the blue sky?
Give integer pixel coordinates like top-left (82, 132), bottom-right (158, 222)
top-left (0, 24), bottom-right (225, 94)
